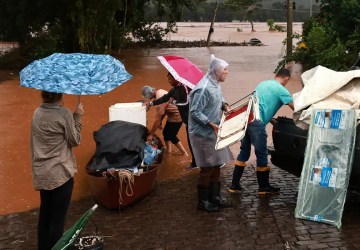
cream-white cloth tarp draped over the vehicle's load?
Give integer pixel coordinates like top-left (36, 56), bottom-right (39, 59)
top-left (293, 65), bottom-right (360, 129)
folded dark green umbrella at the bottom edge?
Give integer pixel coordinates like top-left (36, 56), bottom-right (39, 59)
top-left (51, 205), bottom-right (98, 250)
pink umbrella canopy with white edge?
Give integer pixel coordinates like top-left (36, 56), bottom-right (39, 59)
top-left (157, 56), bottom-right (204, 89)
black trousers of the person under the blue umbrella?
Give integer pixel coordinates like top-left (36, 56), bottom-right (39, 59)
top-left (38, 178), bottom-right (74, 250)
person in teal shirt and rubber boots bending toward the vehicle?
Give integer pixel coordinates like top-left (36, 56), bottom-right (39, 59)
top-left (228, 68), bottom-right (294, 194)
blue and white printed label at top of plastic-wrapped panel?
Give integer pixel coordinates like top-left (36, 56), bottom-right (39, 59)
top-left (314, 109), bottom-right (348, 129)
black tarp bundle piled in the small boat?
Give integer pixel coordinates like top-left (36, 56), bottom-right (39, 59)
top-left (86, 121), bottom-right (148, 172)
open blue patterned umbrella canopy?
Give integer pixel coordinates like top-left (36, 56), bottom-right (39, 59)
top-left (20, 53), bottom-right (132, 95)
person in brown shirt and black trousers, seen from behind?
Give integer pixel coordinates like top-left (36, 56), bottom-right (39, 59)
top-left (30, 91), bottom-right (84, 250)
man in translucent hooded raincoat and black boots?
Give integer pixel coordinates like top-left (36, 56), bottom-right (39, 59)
top-left (189, 55), bottom-right (234, 212)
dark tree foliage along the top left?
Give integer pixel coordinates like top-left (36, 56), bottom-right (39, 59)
top-left (0, 0), bottom-right (197, 58)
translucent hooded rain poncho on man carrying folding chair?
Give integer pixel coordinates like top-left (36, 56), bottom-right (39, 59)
top-left (189, 55), bottom-right (233, 167)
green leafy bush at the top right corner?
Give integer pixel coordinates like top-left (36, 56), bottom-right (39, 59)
top-left (276, 0), bottom-right (360, 71)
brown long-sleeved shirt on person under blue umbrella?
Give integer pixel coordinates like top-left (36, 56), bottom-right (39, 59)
top-left (30, 103), bottom-right (82, 190)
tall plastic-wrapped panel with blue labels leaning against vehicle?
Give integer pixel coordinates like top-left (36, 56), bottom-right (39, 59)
top-left (295, 109), bottom-right (356, 228)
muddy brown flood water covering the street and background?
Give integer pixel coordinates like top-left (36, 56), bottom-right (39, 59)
top-left (0, 23), bottom-right (301, 214)
